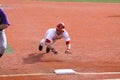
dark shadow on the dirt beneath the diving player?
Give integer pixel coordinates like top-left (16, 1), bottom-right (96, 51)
top-left (23, 53), bottom-right (62, 64)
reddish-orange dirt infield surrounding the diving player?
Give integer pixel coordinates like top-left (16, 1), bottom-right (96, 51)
top-left (0, 0), bottom-right (120, 80)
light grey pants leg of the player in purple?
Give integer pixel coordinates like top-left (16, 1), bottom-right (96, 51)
top-left (0, 31), bottom-right (7, 57)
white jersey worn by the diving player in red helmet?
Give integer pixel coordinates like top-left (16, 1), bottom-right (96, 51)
top-left (45, 28), bottom-right (70, 42)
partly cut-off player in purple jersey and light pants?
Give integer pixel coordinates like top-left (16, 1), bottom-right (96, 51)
top-left (0, 8), bottom-right (10, 58)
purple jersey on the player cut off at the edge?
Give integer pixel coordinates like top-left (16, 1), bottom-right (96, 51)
top-left (0, 8), bottom-right (10, 31)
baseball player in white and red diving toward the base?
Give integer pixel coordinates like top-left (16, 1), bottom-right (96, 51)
top-left (39, 22), bottom-right (71, 54)
